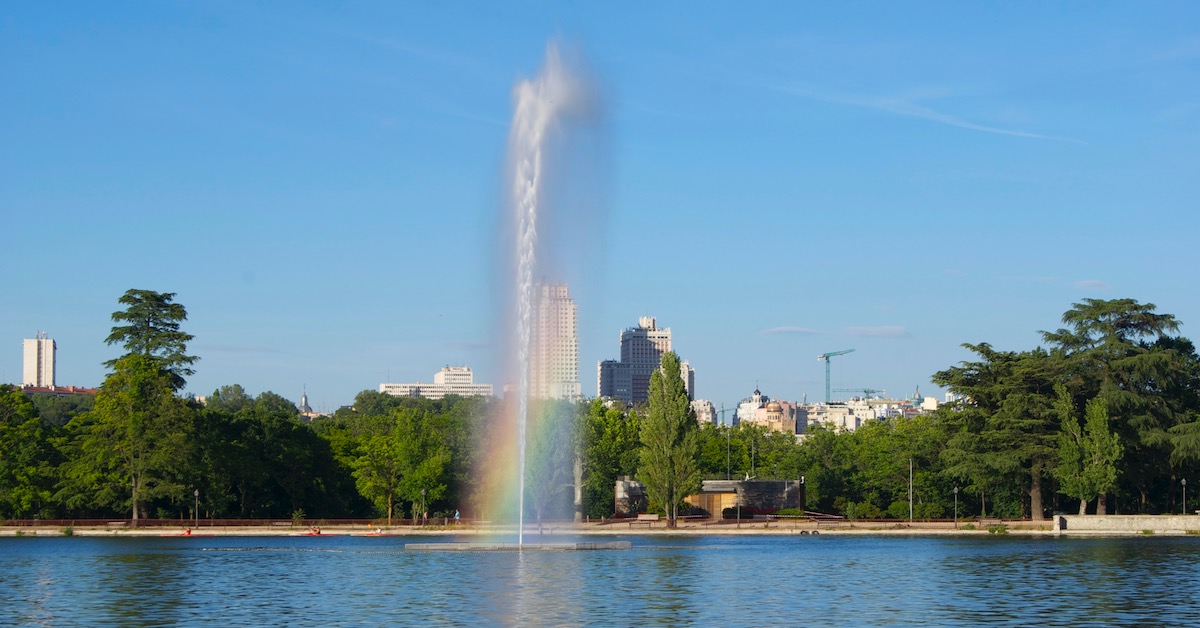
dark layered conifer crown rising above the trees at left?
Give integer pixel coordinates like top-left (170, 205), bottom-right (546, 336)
top-left (104, 289), bottom-right (198, 390)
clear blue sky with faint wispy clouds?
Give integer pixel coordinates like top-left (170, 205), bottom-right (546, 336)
top-left (0, 1), bottom-right (1200, 411)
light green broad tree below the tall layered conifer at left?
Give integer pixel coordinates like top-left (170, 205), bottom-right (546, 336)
top-left (60, 354), bottom-right (193, 524)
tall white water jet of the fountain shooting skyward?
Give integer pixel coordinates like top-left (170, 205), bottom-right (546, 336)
top-left (509, 43), bottom-right (592, 545)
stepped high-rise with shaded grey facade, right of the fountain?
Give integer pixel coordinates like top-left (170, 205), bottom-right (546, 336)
top-left (596, 316), bottom-right (696, 405)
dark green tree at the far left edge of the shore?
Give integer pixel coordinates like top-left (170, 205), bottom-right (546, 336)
top-left (0, 384), bottom-right (56, 519)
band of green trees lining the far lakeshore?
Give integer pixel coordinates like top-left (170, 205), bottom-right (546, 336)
top-left (0, 291), bottom-right (1200, 525)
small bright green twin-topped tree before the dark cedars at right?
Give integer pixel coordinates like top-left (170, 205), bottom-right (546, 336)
top-left (1055, 385), bottom-right (1121, 515)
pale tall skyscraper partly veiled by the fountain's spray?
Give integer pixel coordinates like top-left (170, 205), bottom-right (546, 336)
top-left (529, 283), bottom-right (583, 400)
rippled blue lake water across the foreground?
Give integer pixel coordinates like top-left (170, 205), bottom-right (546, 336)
top-left (0, 536), bottom-right (1200, 626)
